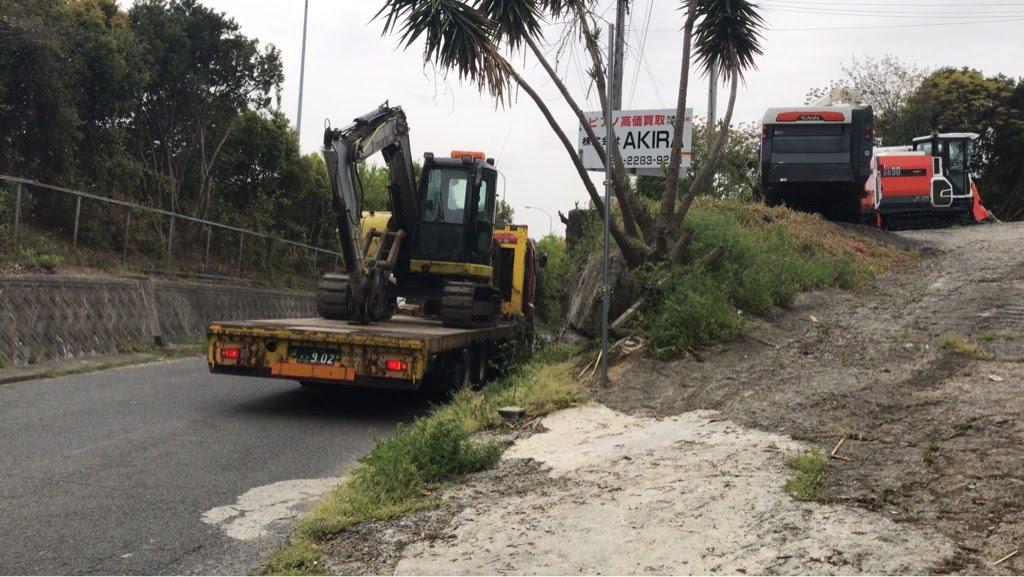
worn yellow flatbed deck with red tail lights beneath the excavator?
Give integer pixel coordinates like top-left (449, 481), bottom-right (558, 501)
top-left (207, 314), bottom-right (522, 389)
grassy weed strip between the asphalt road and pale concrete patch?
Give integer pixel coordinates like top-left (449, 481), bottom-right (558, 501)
top-left (259, 345), bottom-right (579, 575)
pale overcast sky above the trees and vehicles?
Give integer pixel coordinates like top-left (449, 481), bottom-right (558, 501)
top-left (161, 0), bottom-right (1024, 237)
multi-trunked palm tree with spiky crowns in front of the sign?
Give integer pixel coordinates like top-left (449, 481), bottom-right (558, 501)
top-left (377, 0), bottom-right (763, 266)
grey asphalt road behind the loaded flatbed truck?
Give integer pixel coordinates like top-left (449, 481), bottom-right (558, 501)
top-left (0, 359), bottom-right (427, 574)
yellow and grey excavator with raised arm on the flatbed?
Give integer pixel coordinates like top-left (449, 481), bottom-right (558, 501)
top-left (316, 102), bottom-right (537, 328)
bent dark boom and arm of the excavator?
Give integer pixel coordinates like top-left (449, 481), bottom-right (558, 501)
top-left (323, 102), bottom-right (419, 322)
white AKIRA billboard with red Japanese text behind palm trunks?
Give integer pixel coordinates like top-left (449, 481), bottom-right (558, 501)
top-left (577, 109), bottom-right (693, 176)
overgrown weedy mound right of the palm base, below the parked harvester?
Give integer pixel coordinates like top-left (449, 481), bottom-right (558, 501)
top-left (637, 198), bottom-right (912, 358)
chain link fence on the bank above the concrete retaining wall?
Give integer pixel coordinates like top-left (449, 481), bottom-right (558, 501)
top-left (0, 175), bottom-right (341, 288)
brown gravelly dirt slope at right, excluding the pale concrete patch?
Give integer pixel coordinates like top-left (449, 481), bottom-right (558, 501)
top-left (595, 223), bottom-right (1024, 574)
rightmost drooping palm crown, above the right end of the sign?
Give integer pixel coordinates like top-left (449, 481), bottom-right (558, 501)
top-left (685, 0), bottom-right (764, 80)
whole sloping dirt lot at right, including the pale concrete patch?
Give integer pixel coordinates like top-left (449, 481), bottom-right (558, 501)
top-left (321, 224), bottom-right (1024, 574)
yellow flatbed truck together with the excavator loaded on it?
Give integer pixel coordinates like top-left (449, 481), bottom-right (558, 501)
top-left (207, 102), bottom-right (544, 389)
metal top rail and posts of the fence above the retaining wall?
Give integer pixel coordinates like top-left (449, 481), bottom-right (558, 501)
top-left (0, 174), bottom-right (341, 273)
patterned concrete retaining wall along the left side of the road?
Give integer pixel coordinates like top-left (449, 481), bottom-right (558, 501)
top-left (0, 275), bottom-right (315, 366)
